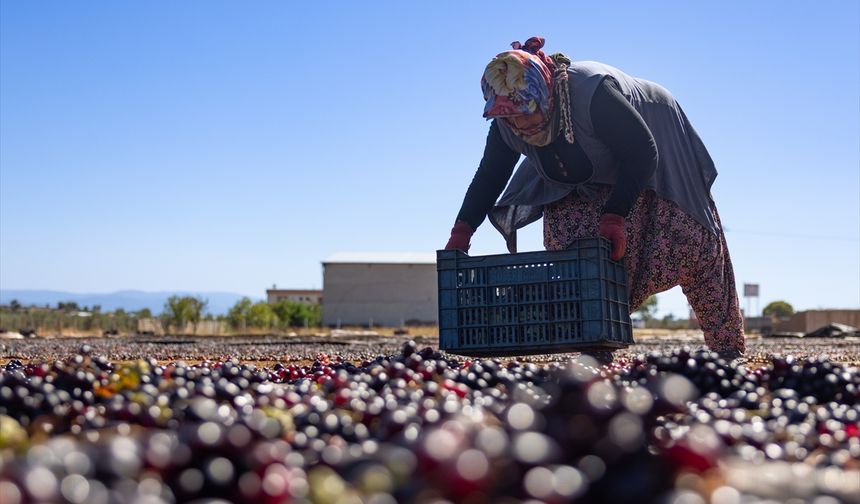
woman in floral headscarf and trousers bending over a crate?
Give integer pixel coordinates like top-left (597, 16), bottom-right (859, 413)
top-left (445, 37), bottom-right (744, 357)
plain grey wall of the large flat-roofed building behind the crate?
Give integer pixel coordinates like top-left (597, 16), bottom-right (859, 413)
top-left (322, 263), bottom-right (439, 327)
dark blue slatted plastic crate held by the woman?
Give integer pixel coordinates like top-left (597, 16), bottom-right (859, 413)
top-left (436, 238), bottom-right (633, 356)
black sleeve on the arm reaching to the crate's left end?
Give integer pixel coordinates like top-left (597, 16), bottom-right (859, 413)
top-left (457, 120), bottom-right (520, 230)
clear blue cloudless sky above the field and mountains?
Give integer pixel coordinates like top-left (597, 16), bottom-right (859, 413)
top-left (0, 0), bottom-right (860, 315)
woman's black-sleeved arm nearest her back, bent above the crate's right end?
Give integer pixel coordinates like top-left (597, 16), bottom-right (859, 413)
top-left (591, 78), bottom-right (658, 217)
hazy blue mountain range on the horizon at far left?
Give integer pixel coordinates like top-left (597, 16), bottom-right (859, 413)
top-left (0, 289), bottom-right (262, 315)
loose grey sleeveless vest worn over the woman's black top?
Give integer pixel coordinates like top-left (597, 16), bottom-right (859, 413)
top-left (489, 61), bottom-right (717, 252)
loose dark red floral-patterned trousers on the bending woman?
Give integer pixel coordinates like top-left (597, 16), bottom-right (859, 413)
top-left (544, 186), bottom-right (744, 351)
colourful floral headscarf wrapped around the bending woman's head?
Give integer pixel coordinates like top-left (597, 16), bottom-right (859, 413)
top-left (481, 37), bottom-right (573, 145)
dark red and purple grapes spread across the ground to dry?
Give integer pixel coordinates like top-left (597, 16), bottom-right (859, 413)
top-left (0, 336), bottom-right (860, 504)
